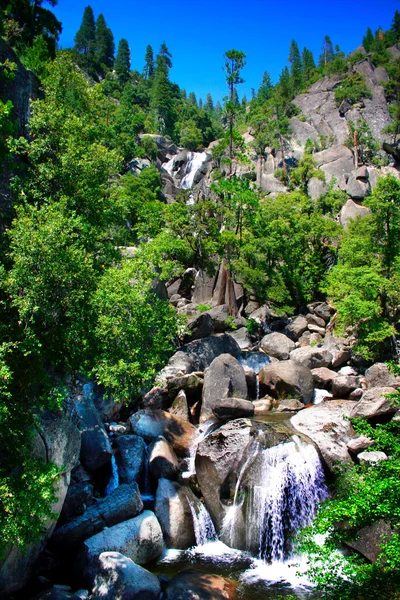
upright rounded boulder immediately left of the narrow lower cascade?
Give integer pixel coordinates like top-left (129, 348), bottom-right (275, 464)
top-left (154, 479), bottom-right (196, 549)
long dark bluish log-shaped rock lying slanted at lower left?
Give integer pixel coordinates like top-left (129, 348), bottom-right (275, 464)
top-left (52, 483), bottom-right (143, 548)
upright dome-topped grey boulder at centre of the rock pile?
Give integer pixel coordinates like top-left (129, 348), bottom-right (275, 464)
top-left (200, 354), bottom-right (247, 423)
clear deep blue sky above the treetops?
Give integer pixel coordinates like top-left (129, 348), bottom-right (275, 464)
top-left (53, 0), bottom-right (400, 100)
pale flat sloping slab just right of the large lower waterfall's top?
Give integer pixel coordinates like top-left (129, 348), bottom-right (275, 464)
top-left (290, 400), bottom-right (356, 469)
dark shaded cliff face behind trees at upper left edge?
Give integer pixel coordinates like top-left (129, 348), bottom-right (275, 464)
top-left (0, 38), bottom-right (42, 212)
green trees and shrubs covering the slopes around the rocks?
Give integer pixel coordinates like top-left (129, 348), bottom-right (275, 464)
top-left (0, 0), bottom-right (400, 598)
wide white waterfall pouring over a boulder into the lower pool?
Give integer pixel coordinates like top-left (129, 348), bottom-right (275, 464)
top-left (222, 436), bottom-right (327, 562)
